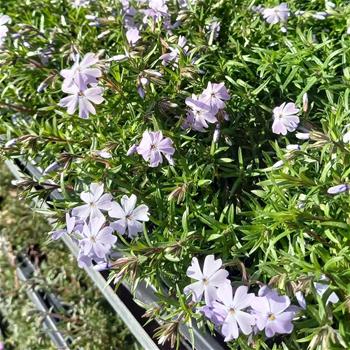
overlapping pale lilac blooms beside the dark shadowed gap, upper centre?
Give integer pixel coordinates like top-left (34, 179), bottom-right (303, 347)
top-left (182, 82), bottom-right (230, 131)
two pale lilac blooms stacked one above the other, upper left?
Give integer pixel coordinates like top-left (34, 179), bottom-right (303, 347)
top-left (59, 53), bottom-right (104, 119)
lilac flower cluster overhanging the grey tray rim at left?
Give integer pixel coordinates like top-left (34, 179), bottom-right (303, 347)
top-left (51, 183), bottom-right (149, 267)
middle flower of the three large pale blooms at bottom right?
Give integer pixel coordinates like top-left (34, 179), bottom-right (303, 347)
top-left (213, 286), bottom-right (255, 342)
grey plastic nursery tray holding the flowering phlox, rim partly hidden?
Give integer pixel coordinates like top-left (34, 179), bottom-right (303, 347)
top-left (5, 159), bottom-right (227, 350)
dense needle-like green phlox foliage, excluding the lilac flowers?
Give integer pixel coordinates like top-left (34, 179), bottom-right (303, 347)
top-left (0, 0), bottom-right (350, 349)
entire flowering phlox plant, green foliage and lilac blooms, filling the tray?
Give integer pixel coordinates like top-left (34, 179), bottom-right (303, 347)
top-left (0, 0), bottom-right (350, 349)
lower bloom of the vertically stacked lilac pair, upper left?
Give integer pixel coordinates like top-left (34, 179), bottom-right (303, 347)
top-left (59, 85), bottom-right (104, 119)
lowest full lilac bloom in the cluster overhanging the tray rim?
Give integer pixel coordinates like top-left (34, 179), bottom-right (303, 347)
top-left (79, 216), bottom-right (117, 258)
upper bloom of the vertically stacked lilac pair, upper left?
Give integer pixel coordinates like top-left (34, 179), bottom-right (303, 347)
top-left (60, 52), bottom-right (102, 92)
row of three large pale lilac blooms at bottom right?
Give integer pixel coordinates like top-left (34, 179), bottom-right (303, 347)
top-left (184, 255), bottom-right (299, 341)
